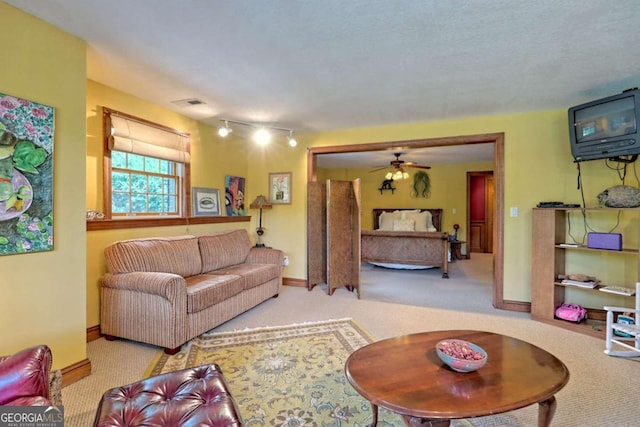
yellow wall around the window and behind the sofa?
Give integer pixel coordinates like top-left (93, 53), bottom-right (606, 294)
top-left (86, 80), bottom-right (255, 327)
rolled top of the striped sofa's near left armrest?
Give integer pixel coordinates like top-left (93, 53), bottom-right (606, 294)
top-left (102, 272), bottom-right (187, 301)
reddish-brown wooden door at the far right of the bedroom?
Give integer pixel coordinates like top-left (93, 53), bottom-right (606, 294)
top-left (467, 171), bottom-right (494, 253)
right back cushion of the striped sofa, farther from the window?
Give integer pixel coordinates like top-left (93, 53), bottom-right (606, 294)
top-left (198, 229), bottom-right (251, 273)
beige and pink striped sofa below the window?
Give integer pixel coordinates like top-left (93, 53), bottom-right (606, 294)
top-left (100, 230), bottom-right (283, 354)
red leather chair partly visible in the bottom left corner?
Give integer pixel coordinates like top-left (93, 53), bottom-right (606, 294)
top-left (0, 345), bottom-right (53, 406)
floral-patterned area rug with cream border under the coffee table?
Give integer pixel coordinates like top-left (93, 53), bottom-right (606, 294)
top-left (148, 319), bottom-right (519, 427)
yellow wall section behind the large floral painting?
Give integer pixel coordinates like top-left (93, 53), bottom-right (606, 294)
top-left (0, 2), bottom-right (86, 368)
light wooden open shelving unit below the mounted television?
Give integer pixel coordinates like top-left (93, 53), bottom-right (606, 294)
top-left (531, 208), bottom-right (640, 339)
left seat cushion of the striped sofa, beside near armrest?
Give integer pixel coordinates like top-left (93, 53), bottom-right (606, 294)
top-left (187, 274), bottom-right (244, 313)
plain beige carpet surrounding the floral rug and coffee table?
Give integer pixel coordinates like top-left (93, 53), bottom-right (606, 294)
top-left (62, 261), bottom-right (640, 427)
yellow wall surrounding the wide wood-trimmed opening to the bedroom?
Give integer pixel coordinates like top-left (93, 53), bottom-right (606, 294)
top-left (268, 110), bottom-right (637, 302)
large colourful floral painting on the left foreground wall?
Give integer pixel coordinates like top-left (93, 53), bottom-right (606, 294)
top-left (0, 93), bottom-right (54, 255)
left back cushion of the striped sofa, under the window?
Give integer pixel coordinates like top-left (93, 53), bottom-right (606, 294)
top-left (105, 236), bottom-right (202, 277)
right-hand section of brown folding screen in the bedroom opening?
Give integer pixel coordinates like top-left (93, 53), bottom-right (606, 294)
top-left (326, 179), bottom-right (360, 298)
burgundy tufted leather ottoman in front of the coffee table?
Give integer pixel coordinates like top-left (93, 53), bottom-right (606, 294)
top-left (93, 364), bottom-right (242, 427)
